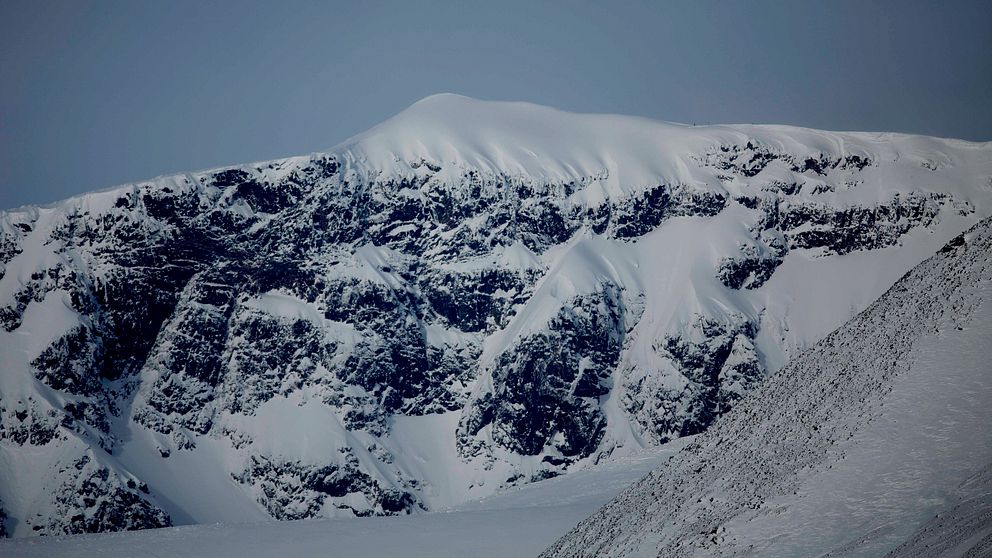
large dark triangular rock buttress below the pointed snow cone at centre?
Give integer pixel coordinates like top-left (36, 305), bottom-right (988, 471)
top-left (460, 285), bottom-right (636, 465)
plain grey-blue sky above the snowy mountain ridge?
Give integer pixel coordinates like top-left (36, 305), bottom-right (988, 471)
top-left (0, 0), bottom-right (992, 208)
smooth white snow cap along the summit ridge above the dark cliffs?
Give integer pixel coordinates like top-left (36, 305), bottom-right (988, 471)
top-left (338, 93), bottom-right (988, 203)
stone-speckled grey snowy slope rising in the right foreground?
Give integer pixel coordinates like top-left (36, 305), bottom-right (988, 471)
top-left (544, 219), bottom-right (992, 556)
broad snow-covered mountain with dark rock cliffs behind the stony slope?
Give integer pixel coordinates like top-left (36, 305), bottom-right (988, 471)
top-left (0, 95), bottom-right (992, 536)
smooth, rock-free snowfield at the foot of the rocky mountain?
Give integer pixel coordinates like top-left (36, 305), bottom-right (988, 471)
top-left (0, 440), bottom-right (682, 558)
